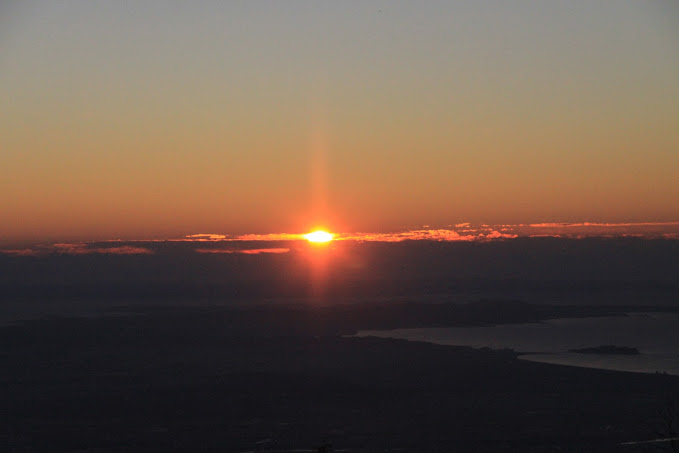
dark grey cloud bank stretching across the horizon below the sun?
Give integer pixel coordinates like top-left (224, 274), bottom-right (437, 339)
top-left (0, 238), bottom-right (679, 303)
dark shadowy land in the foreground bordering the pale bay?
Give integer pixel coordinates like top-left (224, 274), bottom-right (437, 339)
top-left (0, 303), bottom-right (679, 452)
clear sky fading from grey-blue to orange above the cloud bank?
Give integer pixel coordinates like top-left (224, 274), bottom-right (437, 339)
top-left (0, 0), bottom-right (679, 240)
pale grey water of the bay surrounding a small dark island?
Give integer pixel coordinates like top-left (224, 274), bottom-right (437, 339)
top-left (358, 313), bottom-right (679, 375)
